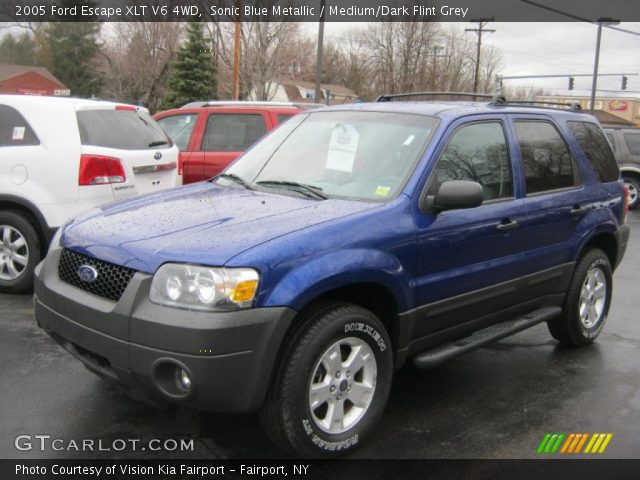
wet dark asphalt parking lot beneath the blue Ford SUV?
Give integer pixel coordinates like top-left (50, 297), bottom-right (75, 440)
top-left (0, 212), bottom-right (640, 459)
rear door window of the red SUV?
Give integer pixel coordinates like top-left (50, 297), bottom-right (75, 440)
top-left (202, 113), bottom-right (267, 152)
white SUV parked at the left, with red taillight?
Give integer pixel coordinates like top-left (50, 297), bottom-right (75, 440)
top-left (0, 95), bottom-right (181, 293)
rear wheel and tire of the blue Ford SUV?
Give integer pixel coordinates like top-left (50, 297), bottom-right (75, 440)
top-left (547, 248), bottom-right (613, 347)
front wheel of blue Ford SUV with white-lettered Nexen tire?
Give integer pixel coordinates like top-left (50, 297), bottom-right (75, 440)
top-left (260, 302), bottom-right (393, 458)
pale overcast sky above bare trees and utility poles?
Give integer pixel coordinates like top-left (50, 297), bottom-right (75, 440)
top-left (318, 22), bottom-right (640, 96)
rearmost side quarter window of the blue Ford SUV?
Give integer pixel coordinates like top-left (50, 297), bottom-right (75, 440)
top-left (567, 122), bottom-right (620, 183)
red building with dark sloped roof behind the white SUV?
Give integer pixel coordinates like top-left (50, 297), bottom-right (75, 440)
top-left (0, 63), bottom-right (70, 95)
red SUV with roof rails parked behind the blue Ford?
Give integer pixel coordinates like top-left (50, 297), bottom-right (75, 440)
top-left (154, 101), bottom-right (322, 184)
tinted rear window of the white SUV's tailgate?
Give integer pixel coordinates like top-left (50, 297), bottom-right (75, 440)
top-left (77, 109), bottom-right (172, 150)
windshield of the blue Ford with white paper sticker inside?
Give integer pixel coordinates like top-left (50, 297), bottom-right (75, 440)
top-left (222, 111), bottom-right (437, 201)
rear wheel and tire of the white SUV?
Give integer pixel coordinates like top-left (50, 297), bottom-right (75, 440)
top-left (0, 210), bottom-right (42, 293)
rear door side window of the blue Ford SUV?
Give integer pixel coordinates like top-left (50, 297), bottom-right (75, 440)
top-left (515, 120), bottom-right (582, 194)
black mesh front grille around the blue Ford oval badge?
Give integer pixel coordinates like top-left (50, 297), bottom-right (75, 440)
top-left (58, 248), bottom-right (136, 302)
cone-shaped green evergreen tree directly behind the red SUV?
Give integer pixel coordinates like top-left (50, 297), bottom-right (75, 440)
top-left (163, 22), bottom-right (217, 108)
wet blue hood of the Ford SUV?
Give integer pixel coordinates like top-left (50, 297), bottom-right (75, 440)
top-left (61, 183), bottom-right (379, 273)
